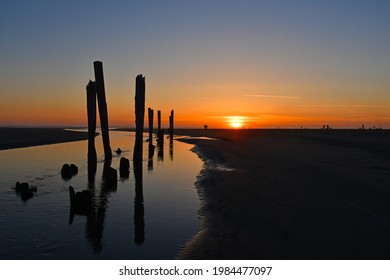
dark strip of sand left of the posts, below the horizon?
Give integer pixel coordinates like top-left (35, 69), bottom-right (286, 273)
top-left (0, 127), bottom-right (88, 150)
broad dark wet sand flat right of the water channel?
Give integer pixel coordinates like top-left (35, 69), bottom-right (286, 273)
top-left (175, 130), bottom-right (390, 260)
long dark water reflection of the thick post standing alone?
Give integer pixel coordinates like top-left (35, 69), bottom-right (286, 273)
top-left (133, 141), bottom-right (145, 246)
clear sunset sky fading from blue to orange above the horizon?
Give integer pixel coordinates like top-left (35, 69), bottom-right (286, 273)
top-left (0, 0), bottom-right (390, 128)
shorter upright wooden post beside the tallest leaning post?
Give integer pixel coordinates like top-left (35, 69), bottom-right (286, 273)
top-left (87, 80), bottom-right (97, 164)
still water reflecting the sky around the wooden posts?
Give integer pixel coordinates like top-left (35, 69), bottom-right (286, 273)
top-left (0, 131), bottom-right (202, 259)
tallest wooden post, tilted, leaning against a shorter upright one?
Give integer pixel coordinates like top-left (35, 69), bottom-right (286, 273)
top-left (93, 61), bottom-right (112, 159)
